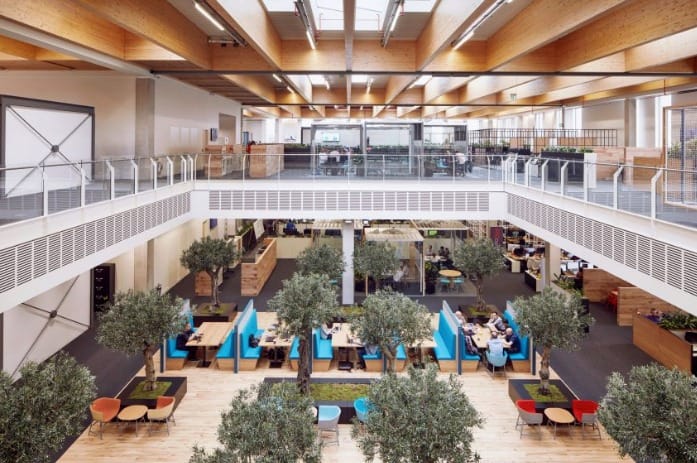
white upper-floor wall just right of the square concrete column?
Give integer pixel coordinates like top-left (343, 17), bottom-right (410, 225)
top-left (154, 77), bottom-right (241, 154)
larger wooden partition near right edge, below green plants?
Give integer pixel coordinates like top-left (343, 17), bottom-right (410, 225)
top-left (632, 315), bottom-right (692, 373)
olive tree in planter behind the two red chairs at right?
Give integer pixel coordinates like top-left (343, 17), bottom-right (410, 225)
top-left (513, 287), bottom-right (595, 394)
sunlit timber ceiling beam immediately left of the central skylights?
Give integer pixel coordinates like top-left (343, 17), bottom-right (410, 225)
top-left (207, 0), bottom-right (282, 69)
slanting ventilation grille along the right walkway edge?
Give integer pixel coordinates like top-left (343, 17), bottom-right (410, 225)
top-left (508, 194), bottom-right (697, 296)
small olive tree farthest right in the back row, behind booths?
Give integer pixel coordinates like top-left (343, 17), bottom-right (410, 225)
top-left (453, 238), bottom-right (504, 311)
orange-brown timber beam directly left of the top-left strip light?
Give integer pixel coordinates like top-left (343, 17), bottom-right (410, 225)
top-left (74, 0), bottom-right (211, 69)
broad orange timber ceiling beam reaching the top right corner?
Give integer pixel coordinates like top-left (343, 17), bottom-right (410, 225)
top-left (557, 0), bottom-right (697, 69)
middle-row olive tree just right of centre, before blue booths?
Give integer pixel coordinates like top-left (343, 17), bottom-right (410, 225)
top-left (351, 290), bottom-right (431, 372)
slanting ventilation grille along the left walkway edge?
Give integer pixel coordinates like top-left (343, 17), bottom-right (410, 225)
top-left (0, 193), bottom-right (191, 293)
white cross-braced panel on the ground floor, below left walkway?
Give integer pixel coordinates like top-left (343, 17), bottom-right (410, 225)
top-left (2, 272), bottom-right (90, 374)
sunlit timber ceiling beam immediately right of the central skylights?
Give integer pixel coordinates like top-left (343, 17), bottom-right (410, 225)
top-left (416, 0), bottom-right (495, 70)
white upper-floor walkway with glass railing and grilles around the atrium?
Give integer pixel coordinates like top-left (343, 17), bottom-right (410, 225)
top-left (0, 154), bottom-right (697, 311)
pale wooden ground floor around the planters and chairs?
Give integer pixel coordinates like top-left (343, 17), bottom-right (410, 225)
top-left (59, 340), bottom-right (632, 463)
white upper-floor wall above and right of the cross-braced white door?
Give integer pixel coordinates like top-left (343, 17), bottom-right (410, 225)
top-left (0, 71), bottom-right (135, 159)
